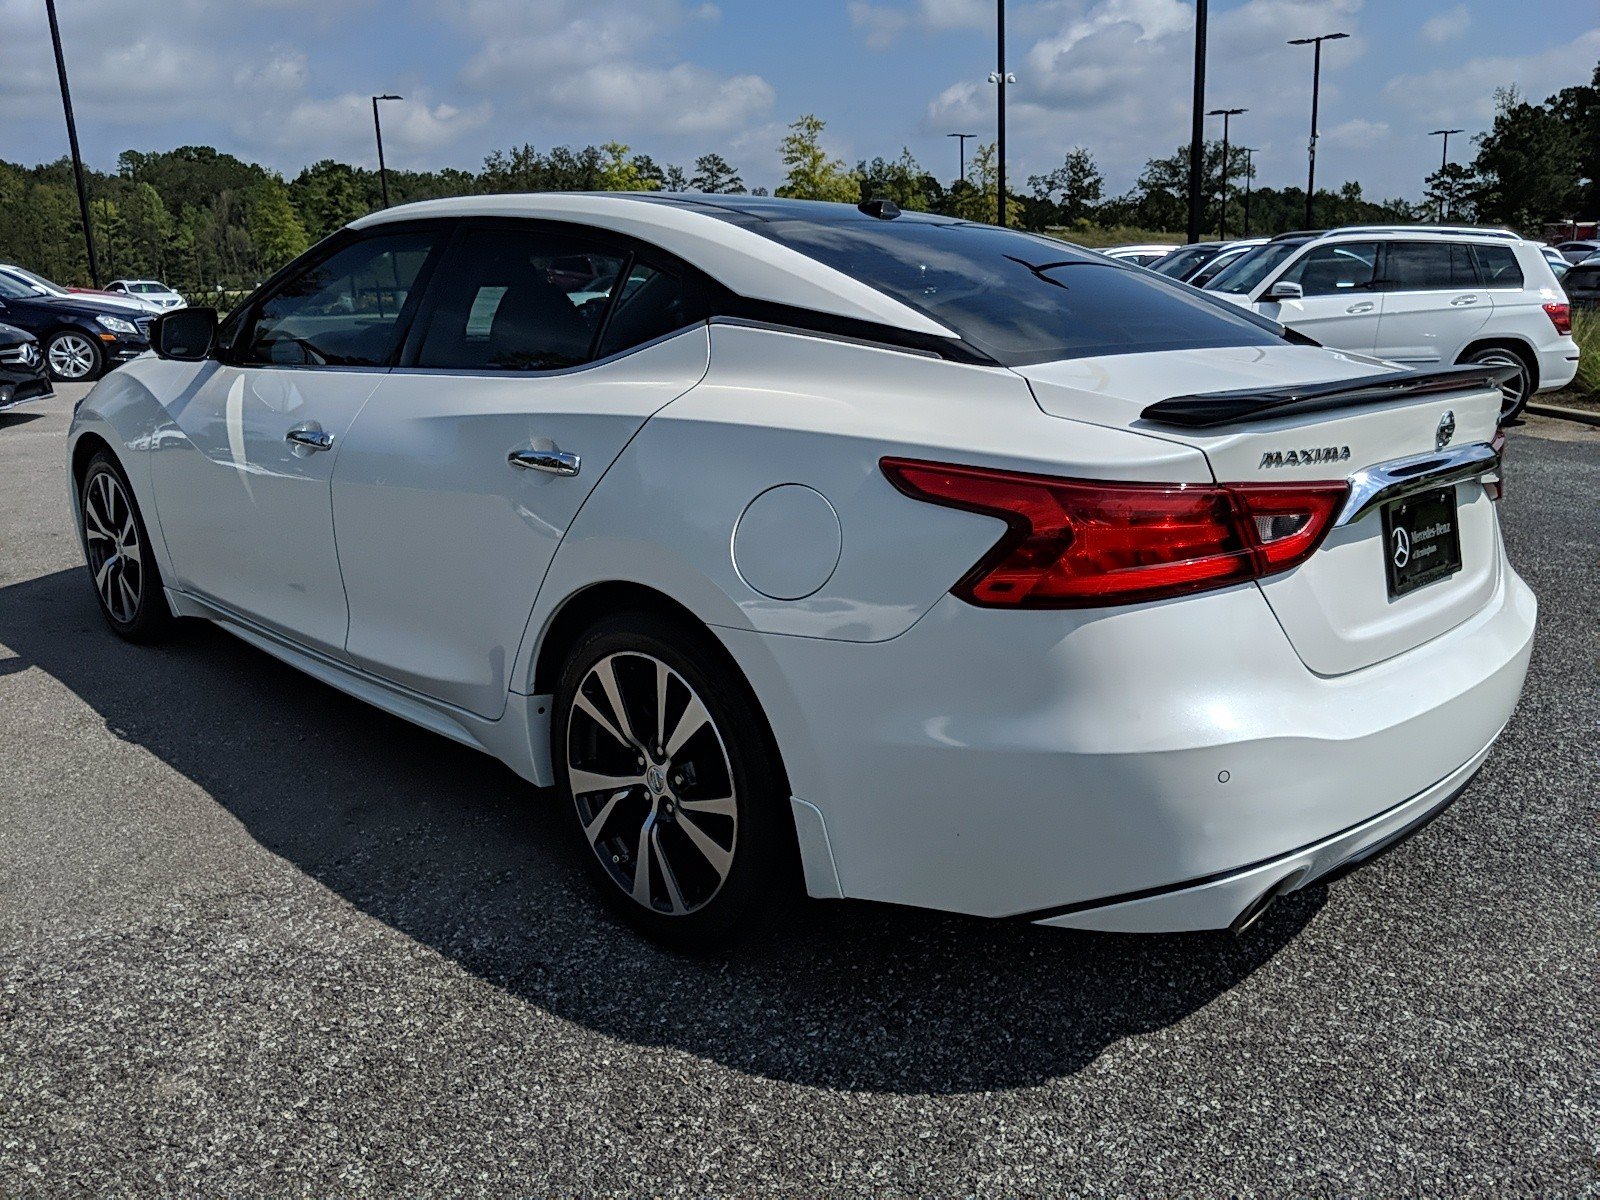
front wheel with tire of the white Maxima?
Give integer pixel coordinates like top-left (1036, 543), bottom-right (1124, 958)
top-left (78, 450), bottom-right (174, 642)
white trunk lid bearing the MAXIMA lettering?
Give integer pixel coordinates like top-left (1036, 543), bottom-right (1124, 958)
top-left (1016, 346), bottom-right (1502, 675)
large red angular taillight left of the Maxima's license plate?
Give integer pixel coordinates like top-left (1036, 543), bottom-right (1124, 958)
top-left (880, 458), bottom-right (1349, 608)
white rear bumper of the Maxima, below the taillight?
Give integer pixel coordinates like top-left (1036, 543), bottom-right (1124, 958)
top-left (718, 566), bottom-right (1538, 930)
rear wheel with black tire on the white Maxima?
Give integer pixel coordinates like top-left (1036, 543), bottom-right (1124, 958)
top-left (554, 614), bottom-right (798, 952)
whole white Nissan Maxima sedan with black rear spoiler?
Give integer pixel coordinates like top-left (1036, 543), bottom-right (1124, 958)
top-left (70, 194), bottom-right (1536, 947)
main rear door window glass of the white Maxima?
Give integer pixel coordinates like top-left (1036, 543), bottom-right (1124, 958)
top-left (418, 229), bottom-right (626, 371)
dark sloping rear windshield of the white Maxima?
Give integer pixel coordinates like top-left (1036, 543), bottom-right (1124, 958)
top-left (713, 211), bottom-right (1282, 366)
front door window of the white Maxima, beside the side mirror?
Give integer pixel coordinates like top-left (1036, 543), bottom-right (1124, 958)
top-left (237, 232), bottom-right (438, 366)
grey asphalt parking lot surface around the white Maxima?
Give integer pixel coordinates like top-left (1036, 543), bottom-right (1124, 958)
top-left (0, 389), bottom-right (1600, 1195)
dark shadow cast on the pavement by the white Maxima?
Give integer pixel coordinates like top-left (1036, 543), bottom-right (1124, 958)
top-left (0, 570), bottom-right (1325, 1093)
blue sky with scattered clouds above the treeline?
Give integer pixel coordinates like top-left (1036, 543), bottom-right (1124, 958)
top-left (0, 0), bottom-right (1600, 197)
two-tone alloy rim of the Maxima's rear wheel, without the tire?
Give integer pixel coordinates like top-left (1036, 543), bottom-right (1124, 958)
top-left (566, 651), bottom-right (739, 917)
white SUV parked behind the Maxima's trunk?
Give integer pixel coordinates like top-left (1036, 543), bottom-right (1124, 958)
top-left (1205, 226), bottom-right (1578, 421)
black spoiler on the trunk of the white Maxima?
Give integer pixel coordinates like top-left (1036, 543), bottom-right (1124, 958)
top-left (1139, 365), bottom-right (1517, 429)
